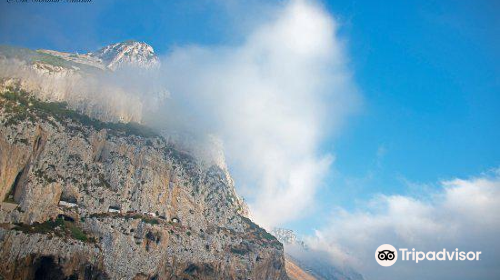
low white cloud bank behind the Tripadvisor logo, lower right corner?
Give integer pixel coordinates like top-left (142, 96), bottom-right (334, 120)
top-left (308, 171), bottom-right (500, 279)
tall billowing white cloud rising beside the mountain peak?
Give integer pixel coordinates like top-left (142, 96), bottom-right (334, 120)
top-left (156, 0), bottom-right (357, 226)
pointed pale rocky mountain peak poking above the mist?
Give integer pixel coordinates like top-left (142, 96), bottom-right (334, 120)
top-left (92, 40), bottom-right (160, 70)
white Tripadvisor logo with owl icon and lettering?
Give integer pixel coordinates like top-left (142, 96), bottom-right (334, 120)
top-left (375, 244), bottom-right (481, 266)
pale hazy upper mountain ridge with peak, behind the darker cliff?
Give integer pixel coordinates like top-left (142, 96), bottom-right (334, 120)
top-left (0, 41), bottom-right (169, 123)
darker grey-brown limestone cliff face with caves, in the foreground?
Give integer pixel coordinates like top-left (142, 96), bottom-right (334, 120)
top-left (0, 88), bottom-right (287, 279)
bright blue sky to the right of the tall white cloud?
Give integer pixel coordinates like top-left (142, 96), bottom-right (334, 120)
top-left (300, 1), bottom-right (500, 234)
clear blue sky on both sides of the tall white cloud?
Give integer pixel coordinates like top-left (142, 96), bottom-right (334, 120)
top-left (0, 1), bottom-right (500, 234)
